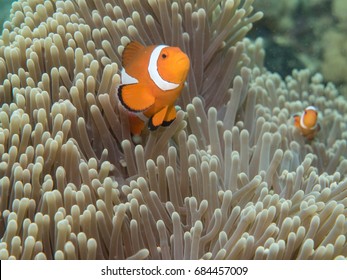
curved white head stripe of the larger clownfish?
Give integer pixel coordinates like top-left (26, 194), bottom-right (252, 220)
top-left (148, 45), bottom-right (179, 91)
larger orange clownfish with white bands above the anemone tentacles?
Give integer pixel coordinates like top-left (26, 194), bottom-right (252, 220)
top-left (118, 41), bottom-right (190, 135)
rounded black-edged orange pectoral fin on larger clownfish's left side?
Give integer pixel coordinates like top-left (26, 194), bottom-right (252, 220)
top-left (118, 84), bottom-right (155, 112)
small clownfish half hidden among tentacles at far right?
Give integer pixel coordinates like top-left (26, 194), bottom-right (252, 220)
top-left (294, 106), bottom-right (320, 140)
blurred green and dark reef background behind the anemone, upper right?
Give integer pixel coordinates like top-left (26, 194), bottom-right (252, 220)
top-left (250, 0), bottom-right (347, 97)
